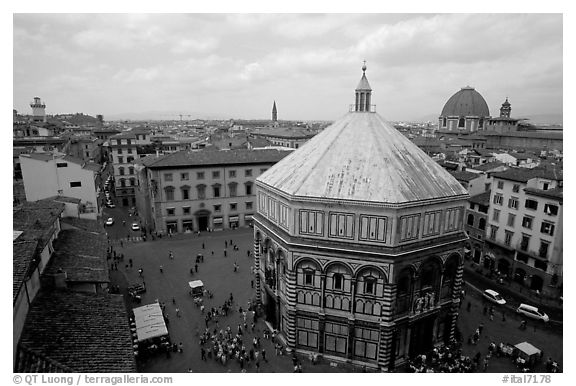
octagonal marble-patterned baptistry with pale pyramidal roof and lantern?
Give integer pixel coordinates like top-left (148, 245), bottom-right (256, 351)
top-left (254, 68), bottom-right (468, 371)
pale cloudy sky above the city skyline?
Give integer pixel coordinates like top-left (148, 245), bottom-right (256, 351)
top-left (13, 13), bottom-right (563, 120)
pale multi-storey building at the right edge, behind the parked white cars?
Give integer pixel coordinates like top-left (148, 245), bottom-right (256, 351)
top-left (484, 168), bottom-right (563, 294)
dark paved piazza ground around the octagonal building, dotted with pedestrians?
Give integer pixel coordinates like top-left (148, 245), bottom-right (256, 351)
top-left (112, 228), bottom-right (563, 373)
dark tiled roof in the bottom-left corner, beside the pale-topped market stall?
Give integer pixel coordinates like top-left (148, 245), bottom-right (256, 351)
top-left (15, 290), bottom-right (136, 373)
